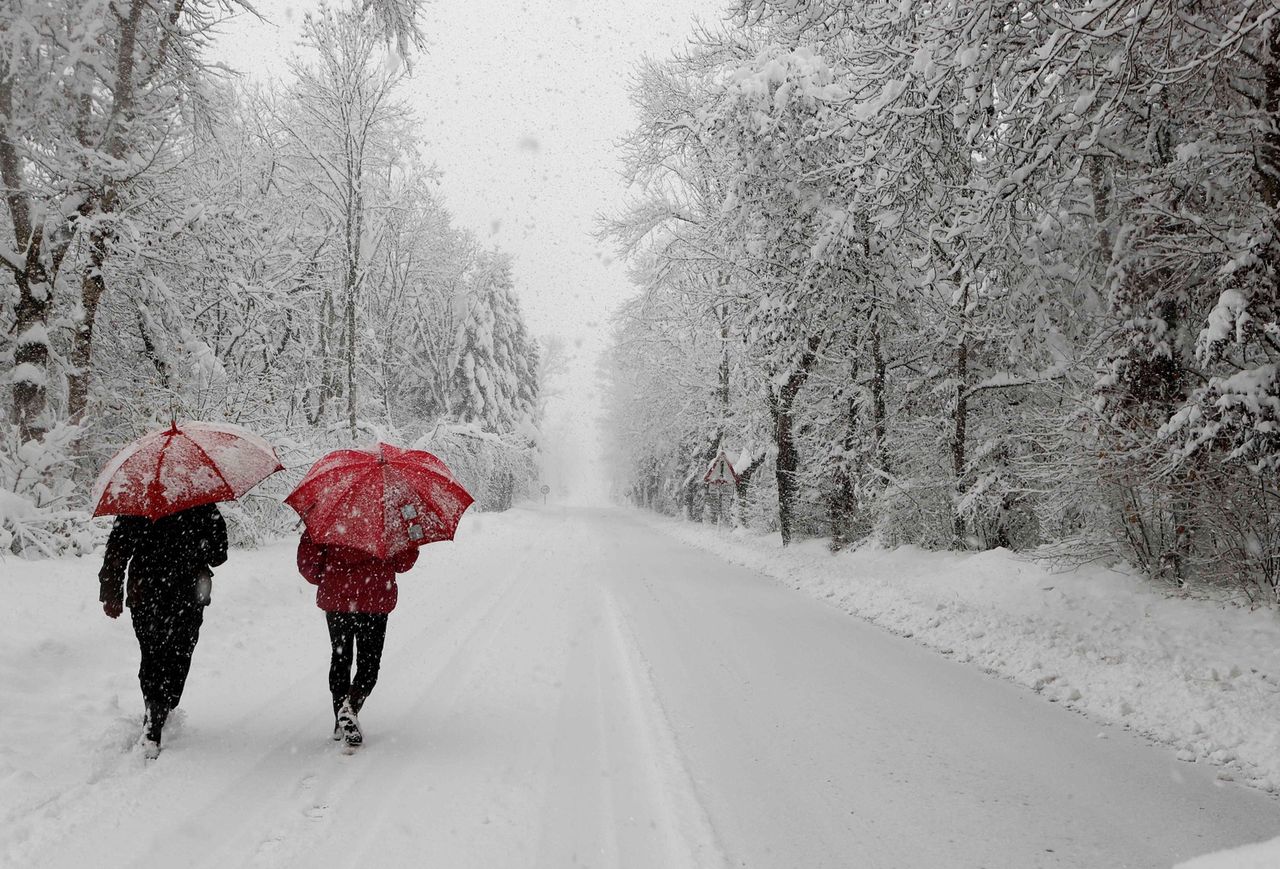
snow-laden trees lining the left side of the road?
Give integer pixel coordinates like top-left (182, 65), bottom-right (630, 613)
top-left (0, 0), bottom-right (550, 553)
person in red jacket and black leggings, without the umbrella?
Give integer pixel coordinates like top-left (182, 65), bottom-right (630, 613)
top-left (298, 532), bottom-right (417, 745)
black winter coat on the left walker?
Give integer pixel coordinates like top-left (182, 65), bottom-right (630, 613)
top-left (97, 504), bottom-right (227, 609)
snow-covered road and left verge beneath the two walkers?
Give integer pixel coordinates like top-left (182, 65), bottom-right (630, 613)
top-left (0, 508), bottom-right (1280, 869)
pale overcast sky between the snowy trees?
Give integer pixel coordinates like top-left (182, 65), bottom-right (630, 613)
top-left (212, 0), bottom-right (727, 500)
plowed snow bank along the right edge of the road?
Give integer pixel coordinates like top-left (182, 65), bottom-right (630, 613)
top-left (654, 520), bottom-right (1280, 793)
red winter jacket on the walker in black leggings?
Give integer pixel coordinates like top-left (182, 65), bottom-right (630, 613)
top-left (298, 534), bottom-right (417, 613)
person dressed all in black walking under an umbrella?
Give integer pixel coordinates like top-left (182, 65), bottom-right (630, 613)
top-left (99, 504), bottom-right (227, 758)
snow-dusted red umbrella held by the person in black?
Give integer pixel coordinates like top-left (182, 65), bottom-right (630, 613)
top-left (92, 422), bottom-right (284, 520)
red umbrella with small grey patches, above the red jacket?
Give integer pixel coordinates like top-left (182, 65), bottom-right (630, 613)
top-left (284, 443), bottom-right (472, 558)
